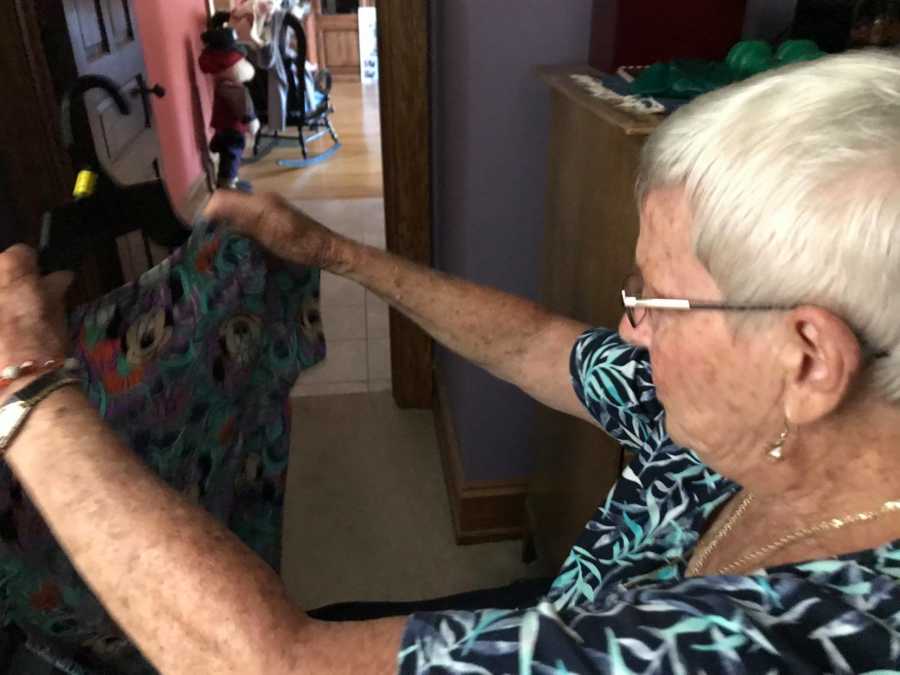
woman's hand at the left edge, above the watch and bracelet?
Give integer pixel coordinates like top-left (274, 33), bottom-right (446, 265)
top-left (0, 245), bottom-right (72, 369)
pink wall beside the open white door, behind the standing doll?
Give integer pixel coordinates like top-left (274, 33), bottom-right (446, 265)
top-left (134, 0), bottom-right (212, 214)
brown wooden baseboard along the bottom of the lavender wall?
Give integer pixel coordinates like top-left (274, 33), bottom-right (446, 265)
top-left (434, 372), bottom-right (527, 544)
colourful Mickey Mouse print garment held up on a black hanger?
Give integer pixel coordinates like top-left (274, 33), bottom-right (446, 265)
top-left (0, 219), bottom-right (325, 674)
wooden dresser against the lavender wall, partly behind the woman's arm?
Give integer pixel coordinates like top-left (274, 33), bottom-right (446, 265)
top-left (527, 66), bottom-right (660, 574)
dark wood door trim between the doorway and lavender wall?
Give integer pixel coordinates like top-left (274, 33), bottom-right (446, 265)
top-left (378, 0), bottom-right (433, 408)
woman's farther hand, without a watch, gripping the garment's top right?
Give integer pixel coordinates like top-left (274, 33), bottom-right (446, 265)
top-left (203, 190), bottom-right (350, 270)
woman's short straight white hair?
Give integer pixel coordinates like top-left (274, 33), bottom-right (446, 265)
top-left (638, 51), bottom-right (900, 402)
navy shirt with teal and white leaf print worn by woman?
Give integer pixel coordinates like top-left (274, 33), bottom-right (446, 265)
top-left (398, 329), bottom-right (900, 674)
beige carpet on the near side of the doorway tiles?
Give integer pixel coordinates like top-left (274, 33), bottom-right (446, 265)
top-left (282, 392), bottom-right (533, 609)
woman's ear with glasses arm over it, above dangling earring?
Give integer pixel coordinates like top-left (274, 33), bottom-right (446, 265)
top-left (781, 306), bottom-right (862, 425)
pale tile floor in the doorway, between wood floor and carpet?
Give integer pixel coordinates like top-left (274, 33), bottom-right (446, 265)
top-left (293, 199), bottom-right (391, 396)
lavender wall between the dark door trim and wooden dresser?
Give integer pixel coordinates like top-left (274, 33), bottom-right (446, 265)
top-left (432, 0), bottom-right (592, 481)
